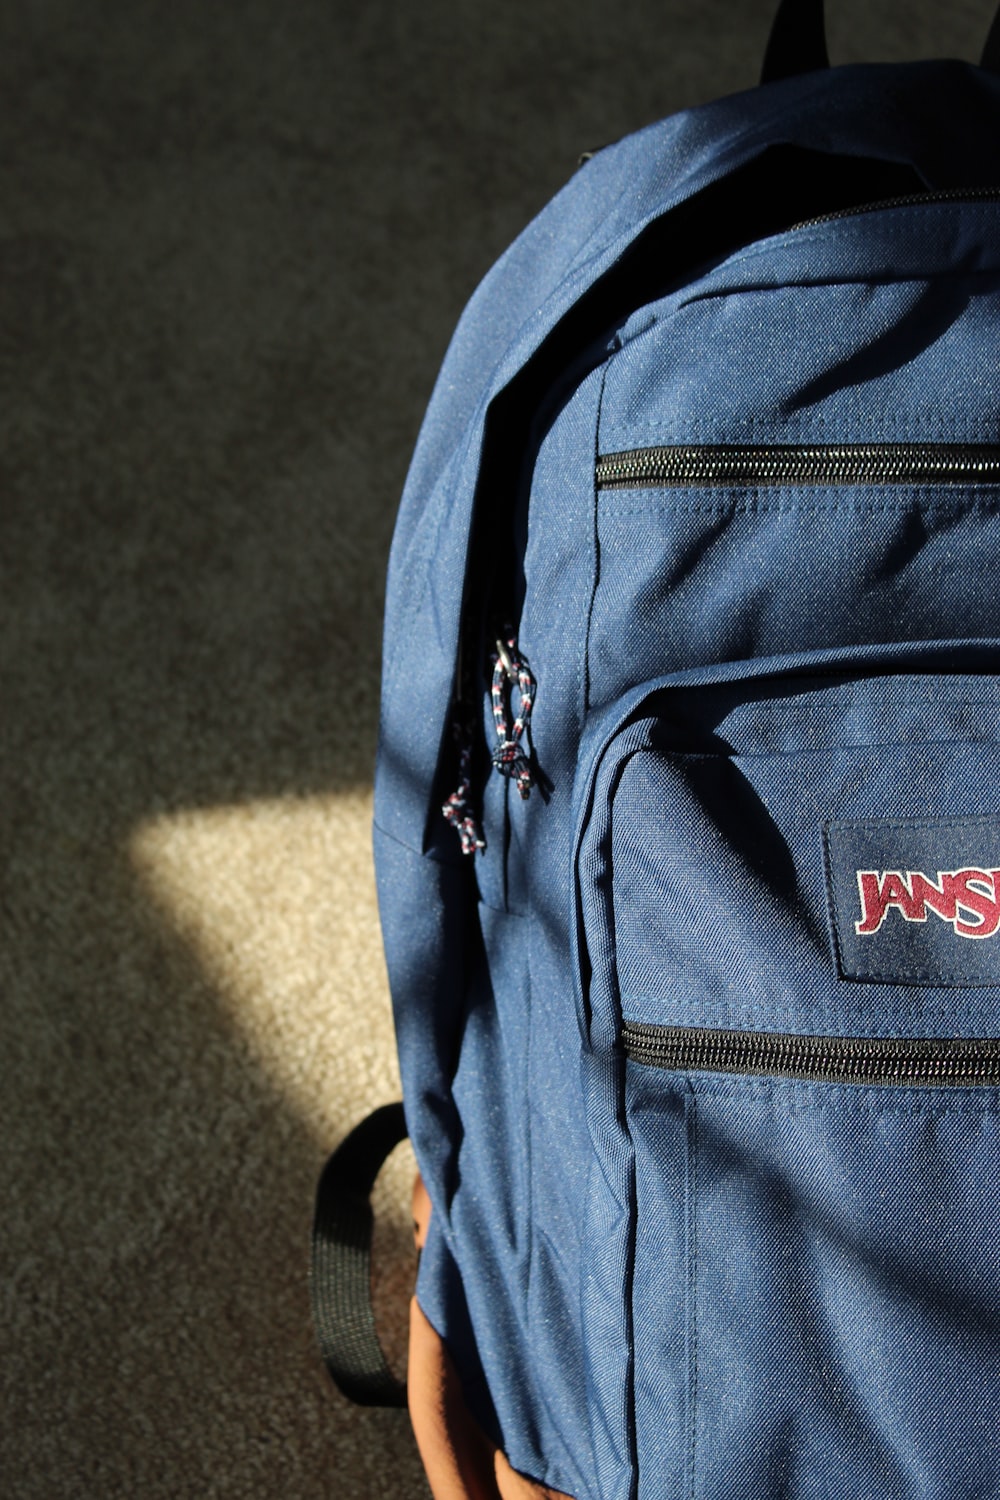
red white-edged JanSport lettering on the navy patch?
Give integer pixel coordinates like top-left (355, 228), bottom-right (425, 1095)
top-left (855, 866), bottom-right (1000, 939)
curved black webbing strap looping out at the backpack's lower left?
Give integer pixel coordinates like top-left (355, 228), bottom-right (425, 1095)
top-left (309, 1104), bottom-right (406, 1407)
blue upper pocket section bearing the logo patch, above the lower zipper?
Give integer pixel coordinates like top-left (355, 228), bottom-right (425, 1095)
top-left (579, 647), bottom-right (1000, 1037)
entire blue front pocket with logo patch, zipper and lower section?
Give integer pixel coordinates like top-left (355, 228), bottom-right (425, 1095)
top-left (577, 648), bottom-right (1000, 1500)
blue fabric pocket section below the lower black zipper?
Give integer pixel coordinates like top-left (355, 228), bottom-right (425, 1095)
top-left (624, 1062), bottom-right (1000, 1500)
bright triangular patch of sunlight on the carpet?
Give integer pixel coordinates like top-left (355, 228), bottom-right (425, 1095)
top-left (129, 792), bottom-right (400, 1139)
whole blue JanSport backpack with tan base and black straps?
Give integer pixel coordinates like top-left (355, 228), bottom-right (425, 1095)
top-left (315, 0), bottom-right (1000, 1500)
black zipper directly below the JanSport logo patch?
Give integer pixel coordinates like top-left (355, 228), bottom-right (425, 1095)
top-left (622, 1022), bottom-right (1000, 1085)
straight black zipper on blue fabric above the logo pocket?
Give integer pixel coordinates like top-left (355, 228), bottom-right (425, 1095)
top-left (595, 443), bottom-right (1000, 489)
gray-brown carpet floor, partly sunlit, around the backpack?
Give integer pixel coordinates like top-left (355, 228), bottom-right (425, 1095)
top-left (0, 0), bottom-right (991, 1500)
